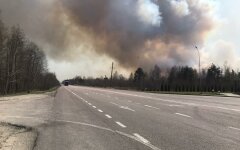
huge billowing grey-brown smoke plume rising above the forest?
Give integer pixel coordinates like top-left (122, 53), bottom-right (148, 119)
top-left (0, 0), bottom-right (218, 68)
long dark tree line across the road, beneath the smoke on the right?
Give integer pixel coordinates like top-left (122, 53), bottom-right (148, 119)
top-left (64, 64), bottom-right (240, 93)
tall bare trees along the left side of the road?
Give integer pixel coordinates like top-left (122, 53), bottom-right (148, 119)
top-left (0, 17), bottom-right (59, 94)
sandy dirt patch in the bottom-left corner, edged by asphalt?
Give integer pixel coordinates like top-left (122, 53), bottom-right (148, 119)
top-left (0, 123), bottom-right (37, 150)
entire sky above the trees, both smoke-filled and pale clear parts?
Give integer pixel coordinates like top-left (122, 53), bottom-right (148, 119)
top-left (0, 0), bottom-right (240, 81)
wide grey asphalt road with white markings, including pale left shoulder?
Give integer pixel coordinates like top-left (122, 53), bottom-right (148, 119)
top-left (0, 86), bottom-right (240, 150)
